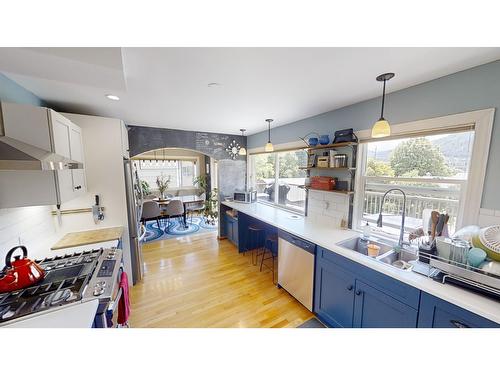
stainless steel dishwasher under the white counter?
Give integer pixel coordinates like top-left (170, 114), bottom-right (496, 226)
top-left (278, 230), bottom-right (316, 311)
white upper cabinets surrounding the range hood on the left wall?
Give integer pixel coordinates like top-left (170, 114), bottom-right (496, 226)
top-left (0, 103), bottom-right (87, 208)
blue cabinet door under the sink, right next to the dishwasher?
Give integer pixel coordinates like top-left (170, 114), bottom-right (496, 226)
top-left (314, 258), bottom-right (356, 328)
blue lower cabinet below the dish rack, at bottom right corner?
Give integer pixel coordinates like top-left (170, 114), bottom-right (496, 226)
top-left (418, 292), bottom-right (500, 328)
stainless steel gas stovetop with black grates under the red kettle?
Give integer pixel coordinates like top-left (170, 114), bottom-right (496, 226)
top-left (0, 249), bottom-right (121, 324)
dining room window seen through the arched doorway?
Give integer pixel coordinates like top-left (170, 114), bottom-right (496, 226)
top-left (137, 160), bottom-right (198, 190)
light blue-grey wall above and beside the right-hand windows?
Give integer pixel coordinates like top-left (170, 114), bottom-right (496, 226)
top-left (247, 60), bottom-right (500, 210)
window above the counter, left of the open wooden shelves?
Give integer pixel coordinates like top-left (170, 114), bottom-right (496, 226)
top-left (249, 150), bottom-right (307, 213)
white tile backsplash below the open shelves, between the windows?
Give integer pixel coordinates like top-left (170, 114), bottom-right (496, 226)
top-left (307, 190), bottom-right (349, 227)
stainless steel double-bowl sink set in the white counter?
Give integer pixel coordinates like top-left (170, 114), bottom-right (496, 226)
top-left (337, 236), bottom-right (418, 271)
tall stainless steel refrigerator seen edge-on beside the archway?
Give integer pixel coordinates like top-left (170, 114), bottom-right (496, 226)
top-left (123, 159), bottom-right (146, 285)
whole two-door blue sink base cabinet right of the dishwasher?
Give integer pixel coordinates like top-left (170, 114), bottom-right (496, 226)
top-left (314, 246), bottom-right (420, 328)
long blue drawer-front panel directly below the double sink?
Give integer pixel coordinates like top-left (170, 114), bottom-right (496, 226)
top-left (318, 246), bottom-right (420, 309)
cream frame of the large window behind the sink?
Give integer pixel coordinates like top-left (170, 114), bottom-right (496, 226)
top-left (352, 108), bottom-right (495, 230)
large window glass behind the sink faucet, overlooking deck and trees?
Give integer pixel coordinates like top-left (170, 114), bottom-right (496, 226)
top-left (358, 131), bottom-right (474, 238)
